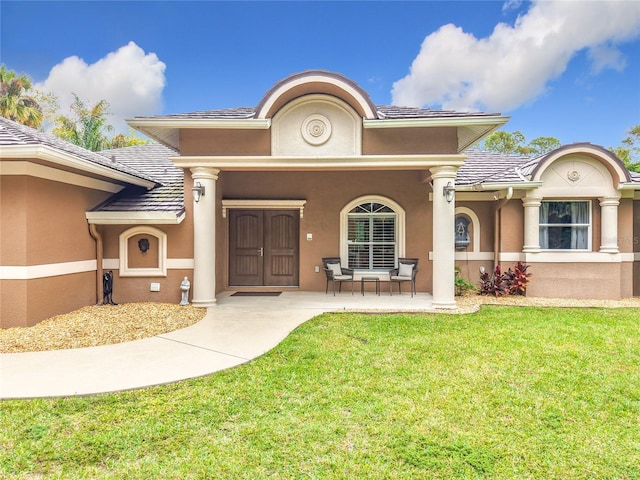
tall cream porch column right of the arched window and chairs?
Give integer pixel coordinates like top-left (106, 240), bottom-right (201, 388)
top-left (431, 166), bottom-right (457, 308)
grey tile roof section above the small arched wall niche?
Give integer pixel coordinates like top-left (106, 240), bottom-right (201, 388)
top-left (91, 143), bottom-right (184, 214)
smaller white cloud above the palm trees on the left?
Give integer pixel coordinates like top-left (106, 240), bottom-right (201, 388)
top-left (35, 42), bottom-right (166, 131)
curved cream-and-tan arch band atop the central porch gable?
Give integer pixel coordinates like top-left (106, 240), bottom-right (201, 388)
top-left (256, 70), bottom-right (378, 120)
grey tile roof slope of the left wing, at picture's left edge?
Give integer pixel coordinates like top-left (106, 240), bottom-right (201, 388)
top-left (0, 117), bottom-right (151, 180)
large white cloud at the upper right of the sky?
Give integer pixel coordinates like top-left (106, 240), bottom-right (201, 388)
top-left (392, 0), bottom-right (640, 111)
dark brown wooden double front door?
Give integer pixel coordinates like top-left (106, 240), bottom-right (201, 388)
top-left (229, 210), bottom-right (300, 286)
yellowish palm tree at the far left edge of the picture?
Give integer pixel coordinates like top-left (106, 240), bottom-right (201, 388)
top-left (0, 65), bottom-right (43, 128)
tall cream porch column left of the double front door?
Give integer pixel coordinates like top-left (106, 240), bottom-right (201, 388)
top-left (191, 167), bottom-right (220, 307)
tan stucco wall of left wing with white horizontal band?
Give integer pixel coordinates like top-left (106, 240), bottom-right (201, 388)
top-left (0, 172), bottom-right (111, 328)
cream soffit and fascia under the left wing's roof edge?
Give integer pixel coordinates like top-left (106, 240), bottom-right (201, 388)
top-left (0, 145), bottom-right (156, 189)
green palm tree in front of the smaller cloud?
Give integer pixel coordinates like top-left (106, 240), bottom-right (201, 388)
top-left (53, 93), bottom-right (113, 152)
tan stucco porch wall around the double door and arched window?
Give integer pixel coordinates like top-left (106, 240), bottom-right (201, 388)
top-left (216, 171), bottom-right (432, 291)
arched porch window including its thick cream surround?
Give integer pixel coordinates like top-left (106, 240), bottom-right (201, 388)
top-left (340, 196), bottom-right (404, 273)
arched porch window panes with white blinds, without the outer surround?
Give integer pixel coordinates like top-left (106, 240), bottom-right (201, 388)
top-left (347, 201), bottom-right (398, 271)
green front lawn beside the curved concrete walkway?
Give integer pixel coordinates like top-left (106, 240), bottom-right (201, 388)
top-left (0, 307), bottom-right (640, 479)
